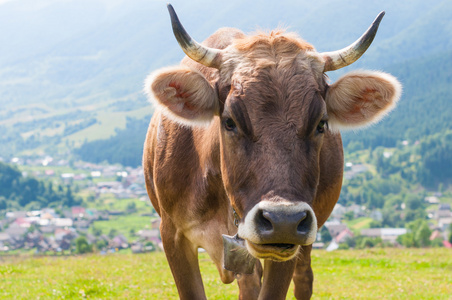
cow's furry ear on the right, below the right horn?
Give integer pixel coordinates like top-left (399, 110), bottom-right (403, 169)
top-left (325, 71), bottom-right (402, 130)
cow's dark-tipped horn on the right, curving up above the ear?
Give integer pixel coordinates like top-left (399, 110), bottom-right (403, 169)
top-left (320, 11), bottom-right (385, 72)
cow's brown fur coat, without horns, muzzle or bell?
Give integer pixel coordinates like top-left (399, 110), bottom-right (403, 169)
top-left (143, 29), bottom-right (396, 299)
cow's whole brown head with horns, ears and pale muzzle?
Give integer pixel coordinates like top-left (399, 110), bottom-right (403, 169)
top-left (146, 6), bottom-right (401, 261)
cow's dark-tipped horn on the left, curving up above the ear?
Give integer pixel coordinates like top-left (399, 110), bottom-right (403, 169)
top-left (168, 3), bottom-right (222, 69)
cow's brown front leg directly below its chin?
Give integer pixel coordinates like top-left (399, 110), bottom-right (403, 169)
top-left (259, 259), bottom-right (296, 300)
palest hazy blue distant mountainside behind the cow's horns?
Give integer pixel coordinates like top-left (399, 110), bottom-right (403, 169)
top-left (0, 0), bottom-right (452, 106)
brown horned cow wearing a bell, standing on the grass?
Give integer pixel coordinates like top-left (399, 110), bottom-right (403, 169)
top-left (143, 4), bottom-right (401, 299)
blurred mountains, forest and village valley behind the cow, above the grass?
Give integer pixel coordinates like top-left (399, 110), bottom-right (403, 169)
top-left (0, 0), bottom-right (452, 253)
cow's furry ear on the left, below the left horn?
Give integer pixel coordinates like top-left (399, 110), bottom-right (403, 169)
top-left (145, 67), bottom-right (219, 126)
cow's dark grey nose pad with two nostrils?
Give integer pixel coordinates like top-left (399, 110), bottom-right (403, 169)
top-left (254, 206), bottom-right (317, 245)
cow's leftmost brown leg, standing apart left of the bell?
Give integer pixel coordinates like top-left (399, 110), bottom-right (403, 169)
top-left (160, 219), bottom-right (206, 300)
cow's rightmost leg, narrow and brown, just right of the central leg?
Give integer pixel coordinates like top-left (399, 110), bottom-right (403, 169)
top-left (293, 245), bottom-right (314, 300)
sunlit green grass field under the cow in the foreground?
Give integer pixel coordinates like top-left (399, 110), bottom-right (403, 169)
top-left (0, 248), bottom-right (452, 299)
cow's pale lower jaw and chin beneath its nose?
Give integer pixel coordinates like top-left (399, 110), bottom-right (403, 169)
top-left (246, 240), bottom-right (300, 262)
